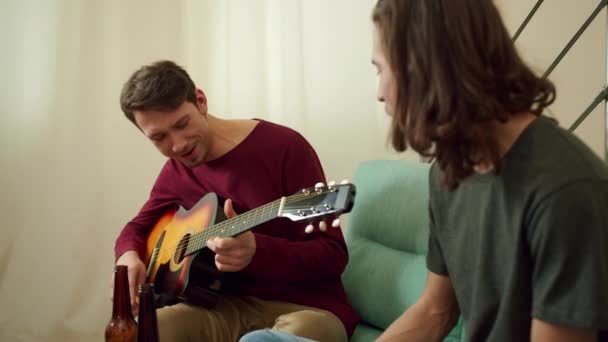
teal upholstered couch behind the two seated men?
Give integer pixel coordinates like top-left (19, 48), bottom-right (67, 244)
top-left (343, 160), bottom-right (465, 342)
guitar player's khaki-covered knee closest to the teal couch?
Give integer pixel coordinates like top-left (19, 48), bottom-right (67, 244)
top-left (273, 310), bottom-right (348, 342)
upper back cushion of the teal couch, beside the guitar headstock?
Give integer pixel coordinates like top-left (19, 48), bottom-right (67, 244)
top-left (347, 160), bottom-right (429, 254)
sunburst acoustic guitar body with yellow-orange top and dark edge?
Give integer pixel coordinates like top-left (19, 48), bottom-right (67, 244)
top-left (146, 193), bottom-right (224, 308)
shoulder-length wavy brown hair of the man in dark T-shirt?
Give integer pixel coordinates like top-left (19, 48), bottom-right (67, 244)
top-left (372, 0), bottom-right (555, 189)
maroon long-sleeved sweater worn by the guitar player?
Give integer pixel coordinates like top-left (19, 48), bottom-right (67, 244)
top-left (115, 121), bottom-right (358, 336)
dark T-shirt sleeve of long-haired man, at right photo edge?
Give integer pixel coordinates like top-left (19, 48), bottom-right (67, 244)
top-left (527, 182), bottom-right (608, 329)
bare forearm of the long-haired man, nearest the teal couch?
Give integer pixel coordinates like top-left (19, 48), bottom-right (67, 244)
top-left (376, 302), bottom-right (460, 342)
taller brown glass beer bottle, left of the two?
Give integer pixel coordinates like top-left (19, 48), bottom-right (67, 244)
top-left (106, 265), bottom-right (137, 342)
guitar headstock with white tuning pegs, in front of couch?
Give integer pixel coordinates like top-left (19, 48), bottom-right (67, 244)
top-left (278, 181), bottom-right (356, 233)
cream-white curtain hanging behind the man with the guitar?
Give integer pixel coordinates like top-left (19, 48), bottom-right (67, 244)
top-left (0, 0), bottom-right (605, 341)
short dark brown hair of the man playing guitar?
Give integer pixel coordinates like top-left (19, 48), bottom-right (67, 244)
top-left (120, 60), bottom-right (197, 125)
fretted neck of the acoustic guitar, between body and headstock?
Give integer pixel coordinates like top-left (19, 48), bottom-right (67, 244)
top-left (186, 197), bottom-right (285, 255)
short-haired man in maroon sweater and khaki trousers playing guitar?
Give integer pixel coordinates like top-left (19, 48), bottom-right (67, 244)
top-left (115, 61), bottom-right (358, 341)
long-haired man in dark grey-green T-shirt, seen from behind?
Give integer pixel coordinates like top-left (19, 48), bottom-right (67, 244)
top-left (372, 0), bottom-right (608, 341)
